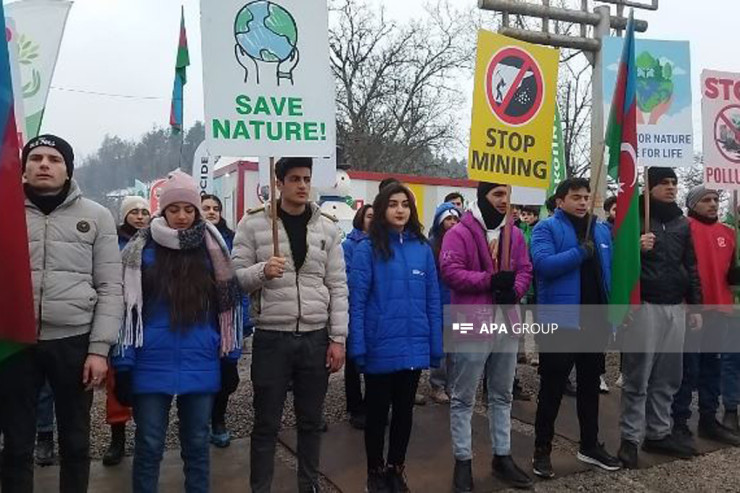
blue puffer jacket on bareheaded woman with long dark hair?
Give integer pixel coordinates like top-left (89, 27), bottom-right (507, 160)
top-left (347, 233), bottom-right (443, 373)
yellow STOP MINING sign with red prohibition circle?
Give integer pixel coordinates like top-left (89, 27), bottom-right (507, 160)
top-left (468, 30), bottom-right (559, 188)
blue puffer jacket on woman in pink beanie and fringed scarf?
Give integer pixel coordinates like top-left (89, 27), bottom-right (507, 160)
top-left (113, 240), bottom-right (221, 395)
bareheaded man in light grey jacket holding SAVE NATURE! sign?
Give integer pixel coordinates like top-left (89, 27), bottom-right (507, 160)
top-left (233, 158), bottom-right (348, 493)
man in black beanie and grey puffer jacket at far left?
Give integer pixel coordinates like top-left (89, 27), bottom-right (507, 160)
top-left (0, 135), bottom-right (123, 493)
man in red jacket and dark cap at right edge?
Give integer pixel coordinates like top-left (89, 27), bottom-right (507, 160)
top-left (673, 186), bottom-right (740, 448)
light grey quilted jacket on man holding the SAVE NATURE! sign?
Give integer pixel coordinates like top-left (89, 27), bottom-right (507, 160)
top-left (232, 204), bottom-right (349, 344)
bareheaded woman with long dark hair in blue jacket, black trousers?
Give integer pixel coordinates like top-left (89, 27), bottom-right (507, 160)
top-left (348, 184), bottom-right (443, 493)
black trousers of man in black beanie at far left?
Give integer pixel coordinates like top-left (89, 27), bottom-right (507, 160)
top-left (0, 335), bottom-right (93, 493)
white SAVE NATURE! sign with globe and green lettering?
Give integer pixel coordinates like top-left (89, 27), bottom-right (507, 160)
top-left (201, 0), bottom-right (336, 157)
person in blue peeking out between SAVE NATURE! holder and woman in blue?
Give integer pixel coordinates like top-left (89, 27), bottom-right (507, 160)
top-left (342, 204), bottom-right (373, 430)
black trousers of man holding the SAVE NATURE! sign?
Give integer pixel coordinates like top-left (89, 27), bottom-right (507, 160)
top-left (250, 330), bottom-right (329, 493)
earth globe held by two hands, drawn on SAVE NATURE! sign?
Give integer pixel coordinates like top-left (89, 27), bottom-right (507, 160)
top-left (234, 0), bottom-right (299, 85)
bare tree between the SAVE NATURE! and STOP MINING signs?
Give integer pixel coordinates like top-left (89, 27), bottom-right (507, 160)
top-left (329, 0), bottom-right (475, 171)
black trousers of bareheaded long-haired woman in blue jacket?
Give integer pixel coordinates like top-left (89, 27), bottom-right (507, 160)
top-left (365, 370), bottom-right (421, 470)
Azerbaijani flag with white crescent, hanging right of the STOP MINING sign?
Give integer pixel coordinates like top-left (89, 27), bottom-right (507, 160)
top-left (606, 13), bottom-right (640, 324)
